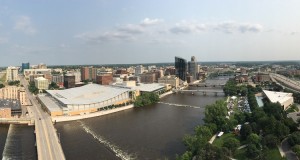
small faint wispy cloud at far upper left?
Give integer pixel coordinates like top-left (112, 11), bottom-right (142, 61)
top-left (14, 16), bottom-right (36, 35)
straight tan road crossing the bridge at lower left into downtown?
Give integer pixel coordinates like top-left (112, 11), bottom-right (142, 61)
top-left (20, 77), bottom-right (65, 160)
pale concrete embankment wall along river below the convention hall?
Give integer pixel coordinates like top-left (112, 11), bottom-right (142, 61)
top-left (51, 104), bottom-right (134, 122)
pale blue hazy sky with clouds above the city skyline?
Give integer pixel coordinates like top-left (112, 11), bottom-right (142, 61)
top-left (0, 0), bottom-right (300, 66)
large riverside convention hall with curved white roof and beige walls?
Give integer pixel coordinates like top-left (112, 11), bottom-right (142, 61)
top-left (38, 84), bottom-right (132, 116)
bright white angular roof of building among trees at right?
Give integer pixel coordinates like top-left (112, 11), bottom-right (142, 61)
top-left (263, 90), bottom-right (293, 104)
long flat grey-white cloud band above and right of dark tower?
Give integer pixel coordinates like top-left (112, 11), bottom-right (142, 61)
top-left (169, 21), bottom-right (263, 34)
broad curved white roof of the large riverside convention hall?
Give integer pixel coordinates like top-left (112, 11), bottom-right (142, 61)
top-left (46, 84), bottom-right (130, 105)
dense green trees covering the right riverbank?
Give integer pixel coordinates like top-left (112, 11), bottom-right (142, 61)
top-left (176, 80), bottom-right (300, 160)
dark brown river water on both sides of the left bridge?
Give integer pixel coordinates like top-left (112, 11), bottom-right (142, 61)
top-left (0, 78), bottom-right (224, 160)
